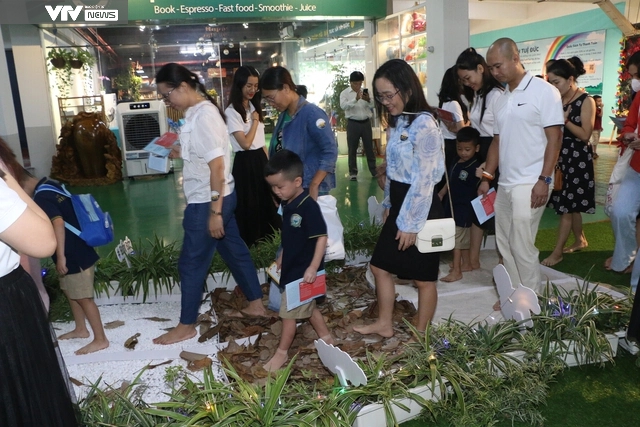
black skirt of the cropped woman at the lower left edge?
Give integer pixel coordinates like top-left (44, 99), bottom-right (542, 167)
top-left (0, 267), bottom-right (78, 427)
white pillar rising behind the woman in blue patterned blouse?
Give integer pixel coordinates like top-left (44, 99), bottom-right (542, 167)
top-left (425, 0), bottom-right (469, 106)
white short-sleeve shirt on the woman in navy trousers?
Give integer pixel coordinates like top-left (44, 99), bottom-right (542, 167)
top-left (180, 100), bottom-right (234, 203)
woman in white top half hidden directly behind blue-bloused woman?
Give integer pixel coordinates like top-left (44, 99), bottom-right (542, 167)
top-left (438, 66), bottom-right (469, 168)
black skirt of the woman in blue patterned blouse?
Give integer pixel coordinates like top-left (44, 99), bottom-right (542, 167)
top-left (371, 181), bottom-right (443, 282)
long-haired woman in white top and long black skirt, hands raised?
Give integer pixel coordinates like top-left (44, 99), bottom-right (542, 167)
top-left (225, 66), bottom-right (281, 246)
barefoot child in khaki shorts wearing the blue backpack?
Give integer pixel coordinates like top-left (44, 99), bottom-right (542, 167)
top-left (34, 178), bottom-right (109, 355)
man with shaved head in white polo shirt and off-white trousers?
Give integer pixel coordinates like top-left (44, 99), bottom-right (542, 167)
top-left (478, 38), bottom-right (564, 292)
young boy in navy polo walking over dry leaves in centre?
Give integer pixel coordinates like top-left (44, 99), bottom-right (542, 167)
top-left (264, 150), bottom-right (333, 372)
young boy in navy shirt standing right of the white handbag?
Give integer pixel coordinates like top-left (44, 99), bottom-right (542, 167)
top-left (438, 126), bottom-right (480, 282)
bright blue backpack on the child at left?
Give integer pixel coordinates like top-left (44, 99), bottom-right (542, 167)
top-left (35, 184), bottom-right (113, 247)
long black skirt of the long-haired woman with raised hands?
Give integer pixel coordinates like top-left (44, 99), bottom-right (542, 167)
top-left (232, 148), bottom-right (282, 246)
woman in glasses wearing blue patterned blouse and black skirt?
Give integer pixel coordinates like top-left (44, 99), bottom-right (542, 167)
top-left (354, 60), bottom-right (445, 337)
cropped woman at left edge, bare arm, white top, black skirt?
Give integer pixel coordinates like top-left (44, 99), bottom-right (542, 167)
top-left (0, 169), bottom-right (78, 427)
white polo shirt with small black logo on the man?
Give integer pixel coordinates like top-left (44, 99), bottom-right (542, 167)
top-left (493, 72), bottom-right (564, 187)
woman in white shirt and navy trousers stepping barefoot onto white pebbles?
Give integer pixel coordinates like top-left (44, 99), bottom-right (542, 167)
top-left (153, 63), bottom-right (266, 344)
